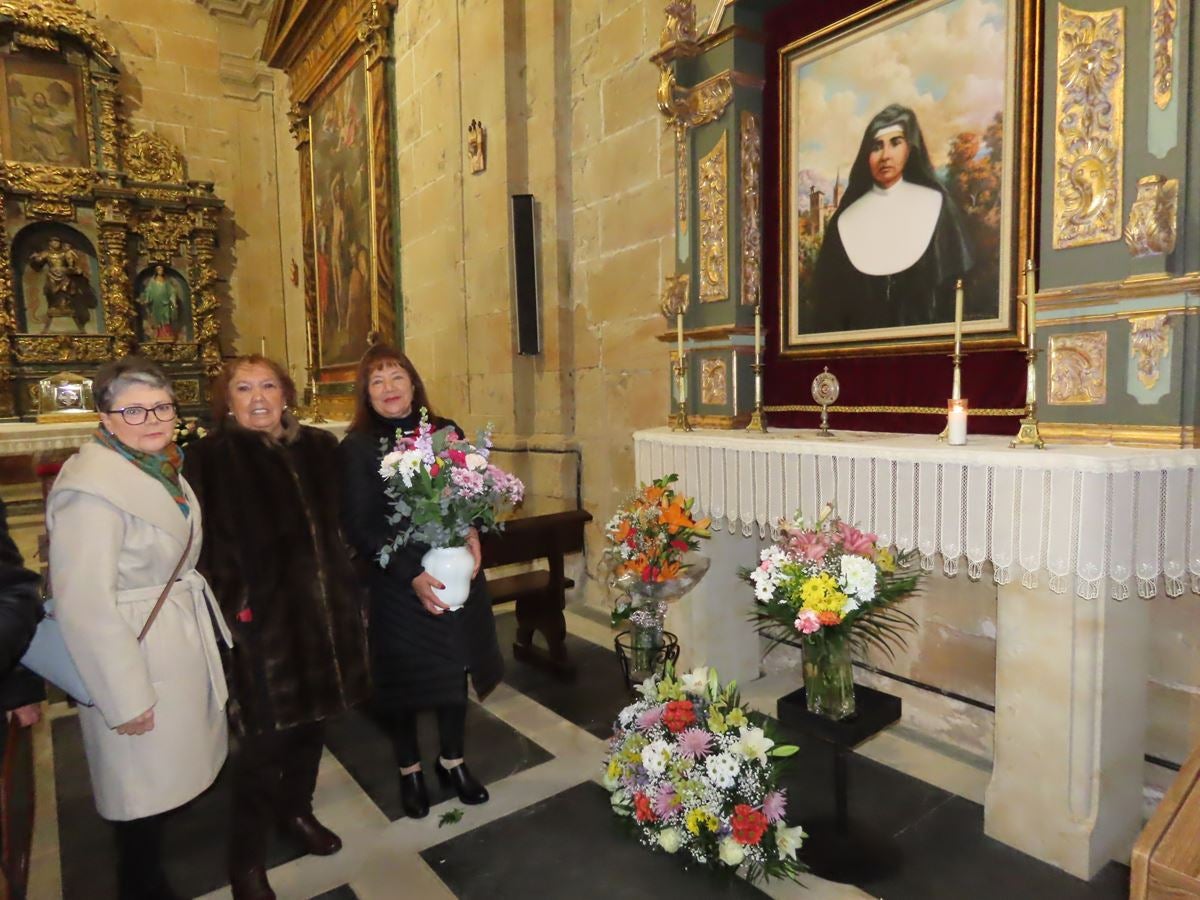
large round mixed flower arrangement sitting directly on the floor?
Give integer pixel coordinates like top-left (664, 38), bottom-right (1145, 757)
top-left (604, 668), bottom-right (805, 881)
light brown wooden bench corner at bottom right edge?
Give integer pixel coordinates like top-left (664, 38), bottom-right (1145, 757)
top-left (1129, 748), bottom-right (1200, 900)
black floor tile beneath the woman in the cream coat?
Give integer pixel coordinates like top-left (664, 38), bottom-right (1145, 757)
top-left (50, 716), bottom-right (301, 900)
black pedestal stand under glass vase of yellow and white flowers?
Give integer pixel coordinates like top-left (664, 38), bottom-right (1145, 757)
top-left (776, 685), bottom-right (902, 883)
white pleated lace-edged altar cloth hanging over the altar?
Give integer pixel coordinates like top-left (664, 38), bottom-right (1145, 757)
top-left (634, 428), bottom-right (1200, 600)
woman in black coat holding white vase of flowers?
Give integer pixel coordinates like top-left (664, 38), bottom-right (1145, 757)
top-left (341, 344), bottom-right (504, 818)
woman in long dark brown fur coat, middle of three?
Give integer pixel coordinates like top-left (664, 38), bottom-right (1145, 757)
top-left (184, 355), bottom-right (368, 900)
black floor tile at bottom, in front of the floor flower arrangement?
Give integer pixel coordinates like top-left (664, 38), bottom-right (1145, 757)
top-left (421, 781), bottom-right (764, 900)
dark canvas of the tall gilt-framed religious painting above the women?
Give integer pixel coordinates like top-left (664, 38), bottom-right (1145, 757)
top-left (304, 64), bottom-right (374, 367)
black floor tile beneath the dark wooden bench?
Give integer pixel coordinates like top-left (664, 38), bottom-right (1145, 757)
top-left (496, 613), bottom-right (630, 738)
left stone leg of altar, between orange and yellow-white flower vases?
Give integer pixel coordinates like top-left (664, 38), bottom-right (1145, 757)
top-left (666, 528), bottom-right (761, 682)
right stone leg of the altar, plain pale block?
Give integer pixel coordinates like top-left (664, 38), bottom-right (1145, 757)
top-left (984, 582), bottom-right (1150, 878)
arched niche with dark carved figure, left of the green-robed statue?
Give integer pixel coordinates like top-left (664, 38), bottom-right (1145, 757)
top-left (12, 223), bottom-right (104, 335)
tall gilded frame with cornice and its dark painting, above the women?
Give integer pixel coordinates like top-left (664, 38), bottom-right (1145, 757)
top-left (263, 0), bottom-right (396, 382)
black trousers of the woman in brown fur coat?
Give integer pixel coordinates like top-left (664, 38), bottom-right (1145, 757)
top-left (229, 722), bottom-right (325, 870)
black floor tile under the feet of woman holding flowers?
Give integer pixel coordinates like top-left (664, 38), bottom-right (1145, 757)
top-left (325, 702), bottom-right (553, 822)
